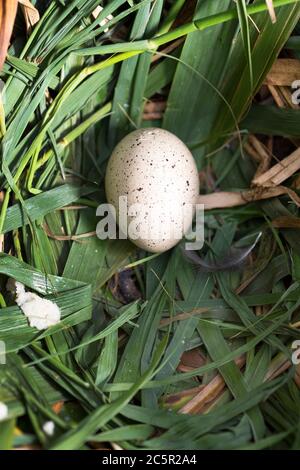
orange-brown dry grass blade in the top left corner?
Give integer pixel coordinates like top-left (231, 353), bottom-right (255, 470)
top-left (0, 0), bottom-right (18, 70)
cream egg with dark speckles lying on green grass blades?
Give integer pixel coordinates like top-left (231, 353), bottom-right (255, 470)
top-left (105, 128), bottom-right (199, 253)
